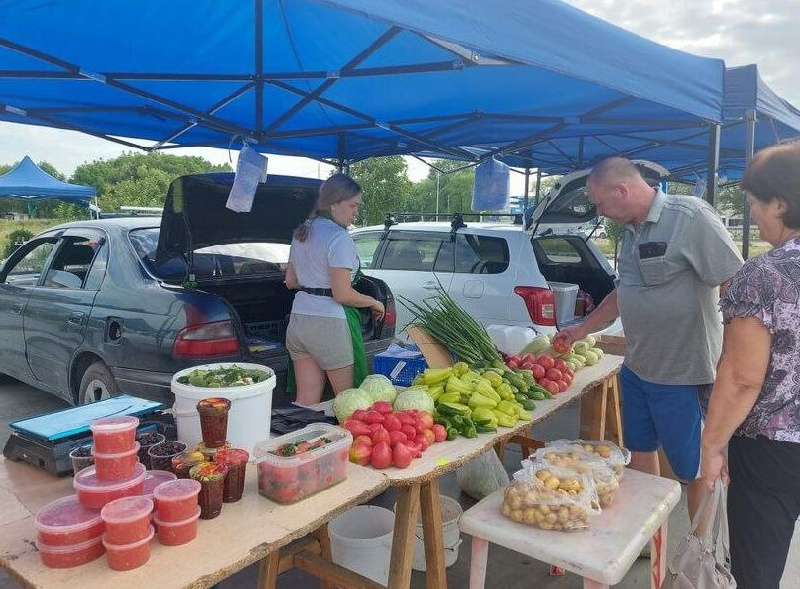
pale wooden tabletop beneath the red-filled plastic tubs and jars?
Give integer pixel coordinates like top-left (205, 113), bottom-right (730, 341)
top-left (0, 459), bottom-right (389, 589)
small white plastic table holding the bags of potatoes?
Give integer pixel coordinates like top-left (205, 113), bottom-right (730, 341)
top-left (460, 469), bottom-right (681, 589)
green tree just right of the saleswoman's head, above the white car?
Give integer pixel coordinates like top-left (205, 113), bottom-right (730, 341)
top-left (350, 155), bottom-right (412, 226)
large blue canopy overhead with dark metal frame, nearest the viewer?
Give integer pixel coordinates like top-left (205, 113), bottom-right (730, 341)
top-left (0, 0), bottom-right (724, 160)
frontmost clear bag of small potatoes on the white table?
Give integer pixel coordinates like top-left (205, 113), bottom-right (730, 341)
top-left (502, 461), bottom-right (600, 531)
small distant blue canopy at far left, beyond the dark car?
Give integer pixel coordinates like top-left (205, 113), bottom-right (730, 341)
top-left (0, 155), bottom-right (95, 205)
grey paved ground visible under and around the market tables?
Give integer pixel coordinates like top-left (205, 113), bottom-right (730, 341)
top-left (0, 376), bottom-right (800, 589)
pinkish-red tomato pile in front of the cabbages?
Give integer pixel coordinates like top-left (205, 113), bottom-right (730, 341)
top-left (343, 401), bottom-right (447, 469)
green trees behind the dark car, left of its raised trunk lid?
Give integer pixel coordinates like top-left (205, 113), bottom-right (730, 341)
top-left (71, 152), bottom-right (231, 211)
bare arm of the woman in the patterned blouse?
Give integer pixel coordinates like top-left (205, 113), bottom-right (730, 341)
top-left (702, 317), bottom-right (772, 489)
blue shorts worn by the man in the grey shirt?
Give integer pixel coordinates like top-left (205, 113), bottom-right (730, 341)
top-left (619, 366), bottom-right (707, 481)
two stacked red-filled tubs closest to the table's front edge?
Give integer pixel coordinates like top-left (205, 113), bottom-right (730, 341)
top-left (100, 497), bottom-right (154, 571)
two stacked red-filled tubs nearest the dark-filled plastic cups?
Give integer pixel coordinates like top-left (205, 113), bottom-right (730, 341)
top-left (153, 479), bottom-right (202, 546)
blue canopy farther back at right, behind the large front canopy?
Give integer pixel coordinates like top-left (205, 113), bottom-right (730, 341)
top-left (476, 65), bottom-right (800, 181)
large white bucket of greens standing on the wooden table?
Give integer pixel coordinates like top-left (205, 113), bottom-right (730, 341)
top-left (171, 362), bottom-right (275, 453)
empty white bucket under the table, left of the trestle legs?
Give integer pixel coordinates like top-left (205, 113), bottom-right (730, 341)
top-left (328, 505), bottom-right (394, 586)
